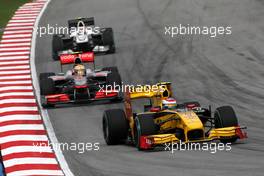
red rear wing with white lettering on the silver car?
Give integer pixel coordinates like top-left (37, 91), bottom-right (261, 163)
top-left (60, 52), bottom-right (95, 71)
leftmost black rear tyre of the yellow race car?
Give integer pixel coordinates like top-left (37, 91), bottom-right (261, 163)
top-left (103, 109), bottom-right (129, 145)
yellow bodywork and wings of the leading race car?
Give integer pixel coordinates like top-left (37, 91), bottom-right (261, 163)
top-left (125, 82), bottom-right (239, 145)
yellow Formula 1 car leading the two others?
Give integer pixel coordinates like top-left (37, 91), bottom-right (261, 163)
top-left (103, 82), bottom-right (247, 150)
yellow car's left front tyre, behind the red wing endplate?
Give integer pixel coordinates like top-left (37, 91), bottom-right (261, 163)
top-left (134, 114), bottom-right (157, 150)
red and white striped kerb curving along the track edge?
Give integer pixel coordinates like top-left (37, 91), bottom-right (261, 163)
top-left (0, 0), bottom-right (64, 176)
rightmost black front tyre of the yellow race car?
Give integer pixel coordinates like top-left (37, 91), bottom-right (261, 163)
top-left (214, 106), bottom-right (238, 143)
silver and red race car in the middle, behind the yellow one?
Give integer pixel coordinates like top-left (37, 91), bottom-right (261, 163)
top-left (39, 52), bottom-right (122, 107)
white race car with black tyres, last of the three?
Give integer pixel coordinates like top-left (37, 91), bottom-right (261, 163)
top-left (52, 17), bottom-right (115, 60)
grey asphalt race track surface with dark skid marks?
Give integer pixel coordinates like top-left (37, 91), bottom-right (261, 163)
top-left (36, 0), bottom-right (264, 176)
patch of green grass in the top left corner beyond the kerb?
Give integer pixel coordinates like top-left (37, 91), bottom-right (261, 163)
top-left (0, 0), bottom-right (29, 40)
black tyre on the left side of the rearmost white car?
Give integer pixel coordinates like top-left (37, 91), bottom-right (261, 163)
top-left (52, 34), bottom-right (64, 60)
